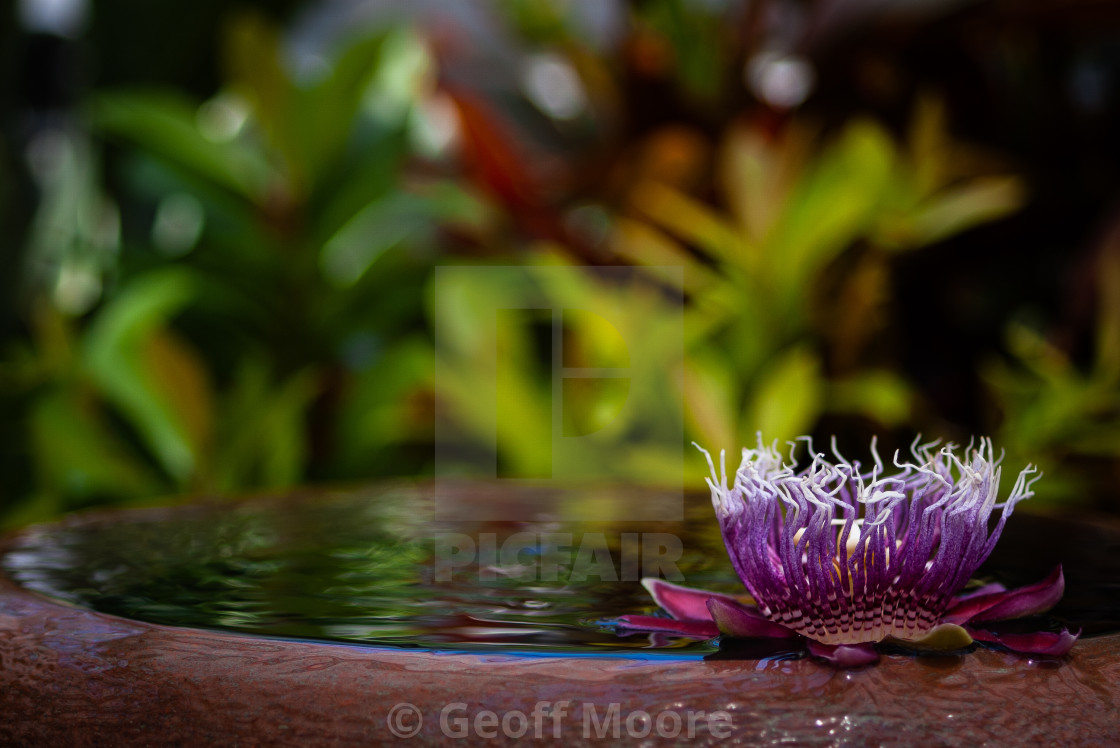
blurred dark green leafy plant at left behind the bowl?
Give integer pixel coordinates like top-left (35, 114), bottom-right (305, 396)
top-left (8, 17), bottom-right (472, 521)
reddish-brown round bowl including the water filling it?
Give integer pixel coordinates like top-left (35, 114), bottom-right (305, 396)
top-left (0, 484), bottom-right (1120, 748)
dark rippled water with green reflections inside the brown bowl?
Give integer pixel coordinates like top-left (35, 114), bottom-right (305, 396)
top-left (0, 485), bottom-right (1120, 656)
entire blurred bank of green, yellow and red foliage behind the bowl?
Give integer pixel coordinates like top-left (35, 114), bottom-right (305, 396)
top-left (0, 0), bottom-right (1120, 524)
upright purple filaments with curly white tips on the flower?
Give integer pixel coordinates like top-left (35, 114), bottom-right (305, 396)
top-left (698, 437), bottom-right (1034, 645)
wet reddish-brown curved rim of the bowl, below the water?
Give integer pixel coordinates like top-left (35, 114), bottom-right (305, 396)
top-left (0, 499), bottom-right (1120, 747)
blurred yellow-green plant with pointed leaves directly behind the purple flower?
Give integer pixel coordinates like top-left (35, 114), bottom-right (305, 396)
top-left (616, 102), bottom-right (1023, 461)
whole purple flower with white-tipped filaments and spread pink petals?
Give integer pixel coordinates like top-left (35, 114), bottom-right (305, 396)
top-left (617, 436), bottom-right (1077, 666)
